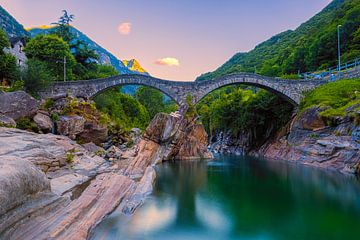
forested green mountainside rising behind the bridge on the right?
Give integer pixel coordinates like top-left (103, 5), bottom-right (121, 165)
top-left (197, 0), bottom-right (360, 80)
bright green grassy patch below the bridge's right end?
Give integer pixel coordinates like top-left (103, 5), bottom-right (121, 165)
top-left (300, 79), bottom-right (360, 118)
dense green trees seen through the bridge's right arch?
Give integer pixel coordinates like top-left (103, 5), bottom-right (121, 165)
top-left (197, 87), bottom-right (292, 146)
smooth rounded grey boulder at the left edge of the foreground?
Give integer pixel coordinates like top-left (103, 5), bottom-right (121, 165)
top-left (0, 156), bottom-right (50, 216)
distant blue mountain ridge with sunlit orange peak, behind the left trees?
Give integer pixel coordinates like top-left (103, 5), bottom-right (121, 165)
top-left (28, 26), bottom-right (148, 75)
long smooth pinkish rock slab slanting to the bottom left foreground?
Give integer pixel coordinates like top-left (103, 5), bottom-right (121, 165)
top-left (6, 173), bottom-right (134, 240)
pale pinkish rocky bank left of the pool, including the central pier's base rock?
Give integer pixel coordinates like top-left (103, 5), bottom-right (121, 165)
top-left (0, 91), bottom-right (212, 239)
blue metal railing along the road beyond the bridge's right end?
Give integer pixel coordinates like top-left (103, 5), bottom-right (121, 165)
top-left (299, 58), bottom-right (360, 80)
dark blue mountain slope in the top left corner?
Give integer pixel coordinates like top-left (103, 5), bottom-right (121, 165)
top-left (0, 6), bottom-right (29, 37)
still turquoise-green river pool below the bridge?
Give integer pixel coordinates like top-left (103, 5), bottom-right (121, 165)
top-left (93, 156), bottom-right (360, 240)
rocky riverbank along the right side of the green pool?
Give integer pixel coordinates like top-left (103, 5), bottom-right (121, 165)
top-left (210, 107), bottom-right (360, 174)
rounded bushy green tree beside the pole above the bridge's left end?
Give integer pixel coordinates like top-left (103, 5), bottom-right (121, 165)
top-left (24, 35), bottom-right (76, 80)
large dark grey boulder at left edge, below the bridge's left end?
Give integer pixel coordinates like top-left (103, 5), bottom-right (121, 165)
top-left (0, 91), bottom-right (39, 120)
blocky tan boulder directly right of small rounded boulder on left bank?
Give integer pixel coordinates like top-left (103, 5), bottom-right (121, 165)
top-left (56, 115), bottom-right (86, 140)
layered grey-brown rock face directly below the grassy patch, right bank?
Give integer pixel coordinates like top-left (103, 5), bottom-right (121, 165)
top-left (257, 108), bottom-right (360, 173)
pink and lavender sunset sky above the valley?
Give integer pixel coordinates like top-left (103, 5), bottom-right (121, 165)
top-left (0, 0), bottom-right (330, 81)
